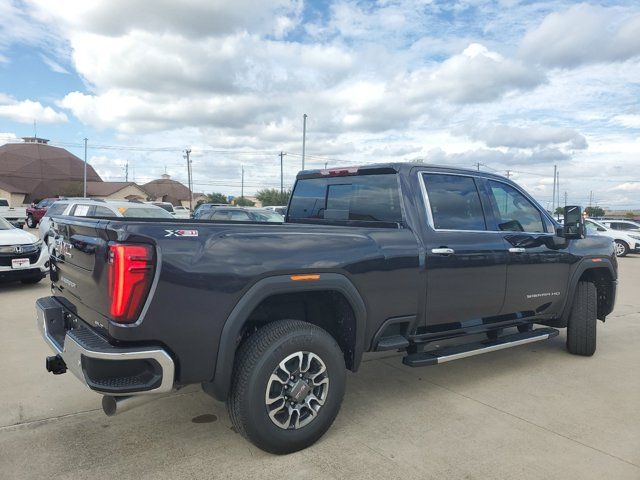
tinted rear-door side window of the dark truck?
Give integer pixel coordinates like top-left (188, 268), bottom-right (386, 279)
top-left (423, 174), bottom-right (487, 230)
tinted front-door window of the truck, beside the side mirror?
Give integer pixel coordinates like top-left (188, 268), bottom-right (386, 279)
top-left (489, 180), bottom-right (546, 232)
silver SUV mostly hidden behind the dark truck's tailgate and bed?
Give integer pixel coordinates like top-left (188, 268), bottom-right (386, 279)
top-left (38, 198), bottom-right (173, 245)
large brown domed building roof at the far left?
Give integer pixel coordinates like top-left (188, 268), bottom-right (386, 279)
top-left (0, 139), bottom-right (102, 201)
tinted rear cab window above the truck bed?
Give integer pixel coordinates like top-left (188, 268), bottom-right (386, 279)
top-left (287, 173), bottom-right (402, 223)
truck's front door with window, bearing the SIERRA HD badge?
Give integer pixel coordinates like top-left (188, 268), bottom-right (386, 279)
top-left (484, 179), bottom-right (571, 317)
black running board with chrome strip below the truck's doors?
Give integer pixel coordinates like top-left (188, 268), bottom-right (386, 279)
top-left (402, 328), bottom-right (560, 367)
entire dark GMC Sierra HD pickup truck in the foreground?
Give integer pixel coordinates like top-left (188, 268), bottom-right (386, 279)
top-left (36, 163), bottom-right (617, 454)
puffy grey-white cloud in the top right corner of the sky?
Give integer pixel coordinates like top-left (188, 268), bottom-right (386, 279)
top-left (521, 3), bottom-right (640, 68)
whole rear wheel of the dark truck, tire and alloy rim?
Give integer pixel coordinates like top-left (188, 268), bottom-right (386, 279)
top-left (227, 320), bottom-right (346, 454)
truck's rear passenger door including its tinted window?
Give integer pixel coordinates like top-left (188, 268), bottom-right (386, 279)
top-left (419, 172), bottom-right (507, 331)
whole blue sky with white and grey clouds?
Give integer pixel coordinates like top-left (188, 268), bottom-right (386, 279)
top-left (0, 0), bottom-right (640, 209)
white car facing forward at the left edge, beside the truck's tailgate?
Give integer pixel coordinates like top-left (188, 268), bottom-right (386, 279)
top-left (0, 218), bottom-right (49, 283)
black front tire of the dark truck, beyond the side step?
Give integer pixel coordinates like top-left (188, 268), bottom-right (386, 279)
top-left (567, 282), bottom-right (598, 357)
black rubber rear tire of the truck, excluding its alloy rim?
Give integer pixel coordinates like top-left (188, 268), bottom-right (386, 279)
top-left (227, 320), bottom-right (346, 454)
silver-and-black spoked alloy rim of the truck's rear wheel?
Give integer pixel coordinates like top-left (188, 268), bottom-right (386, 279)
top-left (265, 351), bottom-right (329, 430)
